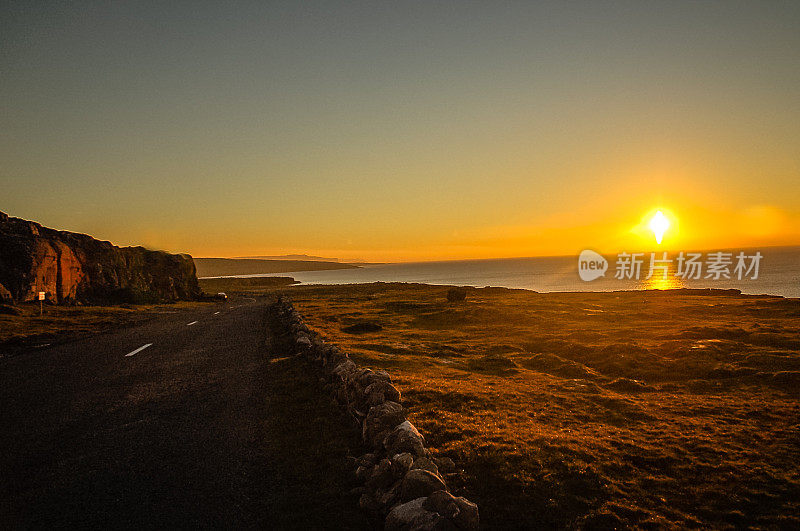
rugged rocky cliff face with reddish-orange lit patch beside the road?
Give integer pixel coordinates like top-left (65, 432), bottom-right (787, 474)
top-left (0, 212), bottom-right (200, 304)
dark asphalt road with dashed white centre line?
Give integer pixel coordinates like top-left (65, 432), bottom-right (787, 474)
top-left (0, 299), bottom-right (366, 528)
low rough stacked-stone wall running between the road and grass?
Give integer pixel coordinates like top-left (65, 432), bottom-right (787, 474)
top-left (269, 298), bottom-right (478, 531)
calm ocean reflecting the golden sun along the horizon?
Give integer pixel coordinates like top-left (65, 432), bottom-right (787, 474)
top-left (212, 246), bottom-right (800, 297)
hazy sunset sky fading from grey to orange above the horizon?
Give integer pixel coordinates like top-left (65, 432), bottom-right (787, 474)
top-left (0, 0), bottom-right (800, 261)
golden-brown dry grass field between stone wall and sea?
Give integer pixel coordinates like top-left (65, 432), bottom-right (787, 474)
top-left (285, 284), bottom-right (800, 528)
